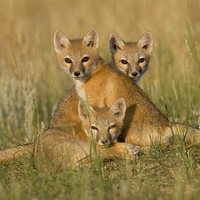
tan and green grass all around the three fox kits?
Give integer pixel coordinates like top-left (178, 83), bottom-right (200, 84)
top-left (0, 0), bottom-right (200, 200)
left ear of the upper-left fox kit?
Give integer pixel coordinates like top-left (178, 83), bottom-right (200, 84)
top-left (54, 31), bottom-right (70, 52)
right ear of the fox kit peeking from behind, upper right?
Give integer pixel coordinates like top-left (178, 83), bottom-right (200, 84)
top-left (137, 31), bottom-right (153, 54)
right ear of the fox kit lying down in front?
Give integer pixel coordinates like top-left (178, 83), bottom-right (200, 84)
top-left (110, 98), bottom-right (126, 119)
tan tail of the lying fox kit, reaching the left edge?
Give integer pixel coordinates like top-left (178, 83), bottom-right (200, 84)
top-left (0, 143), bottom-right (34, 162)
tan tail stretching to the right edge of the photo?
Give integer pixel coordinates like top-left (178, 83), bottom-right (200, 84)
top-left (172, 123), bottom-right (200, 146)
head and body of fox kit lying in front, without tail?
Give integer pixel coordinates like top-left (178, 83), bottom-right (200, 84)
top-left (35, 98), bottom-right (140, 170)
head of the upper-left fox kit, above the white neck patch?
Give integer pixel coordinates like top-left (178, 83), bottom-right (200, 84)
top-left (54, 29), bottom-right (99, 82)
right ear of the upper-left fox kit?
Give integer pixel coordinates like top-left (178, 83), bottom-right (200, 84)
top-left (83, 29), bottom-right (99, 48)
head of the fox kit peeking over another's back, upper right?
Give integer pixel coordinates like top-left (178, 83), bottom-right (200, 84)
top-left (110, 31), bottom-right (153, 83)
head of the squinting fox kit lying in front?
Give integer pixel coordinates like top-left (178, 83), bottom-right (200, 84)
top-left (78, 98), bottom-right (126, 146)
